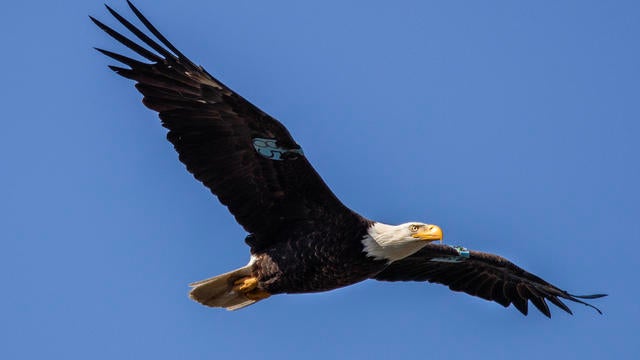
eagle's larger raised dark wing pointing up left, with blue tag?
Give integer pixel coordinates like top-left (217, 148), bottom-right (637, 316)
top-left (91, 1), bottom-right (353, 241)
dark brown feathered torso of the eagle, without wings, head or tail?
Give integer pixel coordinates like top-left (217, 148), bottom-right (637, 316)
top-left (247, 216), bottom-right (378, 294)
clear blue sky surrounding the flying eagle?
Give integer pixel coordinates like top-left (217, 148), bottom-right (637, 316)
top-left (0, 0), bottom-right (640, 359)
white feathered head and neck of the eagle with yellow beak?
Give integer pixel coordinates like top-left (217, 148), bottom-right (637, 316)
top-left (362, 222), bottom-right (442, 262)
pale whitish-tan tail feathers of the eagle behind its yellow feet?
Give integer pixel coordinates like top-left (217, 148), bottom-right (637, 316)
top-left (189, 265), bottom-right (259, 310)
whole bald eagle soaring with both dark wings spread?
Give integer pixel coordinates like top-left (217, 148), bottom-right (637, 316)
top-left (90, 1), bottom-right (605, 317)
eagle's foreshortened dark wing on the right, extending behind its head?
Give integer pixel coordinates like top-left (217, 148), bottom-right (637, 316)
top-left (375, 244), bottom-right (605, 317)
